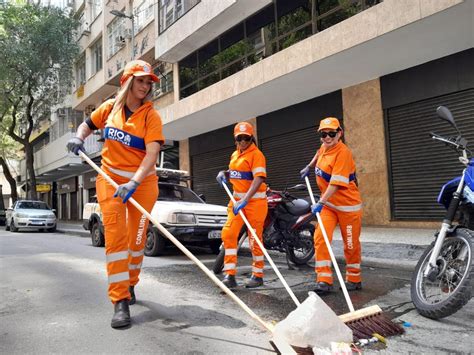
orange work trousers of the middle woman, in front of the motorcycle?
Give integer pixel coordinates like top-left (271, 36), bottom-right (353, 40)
top-left (222, 199), bottom-right (268, 277)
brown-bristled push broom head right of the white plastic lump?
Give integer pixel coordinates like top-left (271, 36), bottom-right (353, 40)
top-left (339, 305), bottom-right (405, 341)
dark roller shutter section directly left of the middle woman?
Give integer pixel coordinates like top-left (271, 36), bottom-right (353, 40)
top-left (191, 146), bottom-right (235, 205)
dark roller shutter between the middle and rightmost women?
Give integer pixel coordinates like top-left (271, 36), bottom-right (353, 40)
top-left (260, 126), bottom-right (321, 196)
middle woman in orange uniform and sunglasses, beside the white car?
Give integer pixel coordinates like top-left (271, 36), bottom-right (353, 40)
top-left (216, 122), bottom-right (268, 288)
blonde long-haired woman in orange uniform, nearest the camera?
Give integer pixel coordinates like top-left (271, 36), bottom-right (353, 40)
top-left (67, 60), bottom-right (165, 328)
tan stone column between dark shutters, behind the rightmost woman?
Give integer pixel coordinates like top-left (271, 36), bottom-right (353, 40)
top-left (342, 79), bottom-right (390, 225)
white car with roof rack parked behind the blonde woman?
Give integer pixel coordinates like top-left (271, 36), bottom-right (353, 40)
top-left (82, 169), bottom-right (227, 256)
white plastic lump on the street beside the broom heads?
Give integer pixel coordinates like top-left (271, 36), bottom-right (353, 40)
top-left (273, 292), bottom-right (352, 348)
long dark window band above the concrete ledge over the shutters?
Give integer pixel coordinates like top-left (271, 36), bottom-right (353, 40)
top-left (178, 0), bottom-right (381, 98)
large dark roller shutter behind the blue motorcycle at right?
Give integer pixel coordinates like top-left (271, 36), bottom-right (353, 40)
top-left (386, 89), bottom-right (474, 220)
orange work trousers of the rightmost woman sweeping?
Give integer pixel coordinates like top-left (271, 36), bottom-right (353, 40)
top-left (314, 206), bottom-right (362, 285)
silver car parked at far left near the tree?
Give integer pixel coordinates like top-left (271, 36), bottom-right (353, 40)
top-left (5, 200), bottom-right (56, 232)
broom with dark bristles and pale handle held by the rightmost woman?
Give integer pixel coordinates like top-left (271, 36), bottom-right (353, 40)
top-left (305, 176), bottom-right (404, 340)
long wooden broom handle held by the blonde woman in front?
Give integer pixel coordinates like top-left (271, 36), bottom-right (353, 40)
top-left (79, 151), bottom-right (274, 332)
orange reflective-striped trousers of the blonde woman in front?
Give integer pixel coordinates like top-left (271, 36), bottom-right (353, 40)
top-left (96, 173), bottom-right (158, 304)
